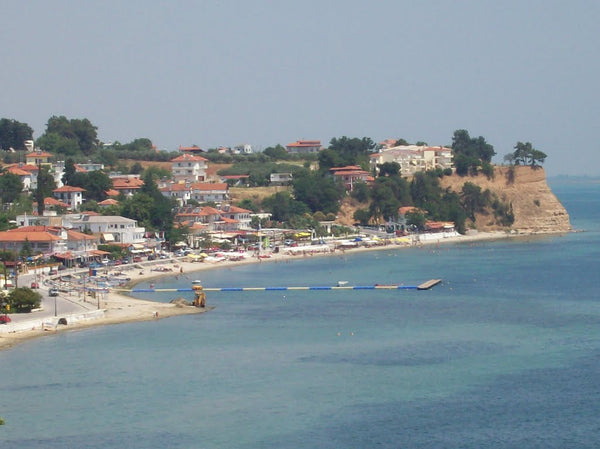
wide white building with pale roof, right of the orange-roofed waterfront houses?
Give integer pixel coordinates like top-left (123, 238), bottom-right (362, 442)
top-left (65, 215), bottom-right (146, 243)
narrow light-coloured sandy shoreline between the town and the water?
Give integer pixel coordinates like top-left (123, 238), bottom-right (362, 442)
top-left (0, 231), bottom-right (565, 351)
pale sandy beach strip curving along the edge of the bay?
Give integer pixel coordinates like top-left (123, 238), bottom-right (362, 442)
top-left (0, 232), bottom-right (552, 350)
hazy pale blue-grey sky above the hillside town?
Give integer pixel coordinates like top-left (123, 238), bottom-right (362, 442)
top-left (0, 0), bottom-right (600, 176)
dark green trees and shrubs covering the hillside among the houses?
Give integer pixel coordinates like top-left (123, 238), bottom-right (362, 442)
top-left (0, 116), bottom-right (546, 239)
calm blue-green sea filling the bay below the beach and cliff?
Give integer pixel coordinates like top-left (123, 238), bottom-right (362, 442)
top-left (0, 178), bottom-right (600, 449)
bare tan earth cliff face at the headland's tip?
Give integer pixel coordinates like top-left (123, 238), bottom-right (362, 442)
top-left (440, 166), bottom-right (571, 233)
